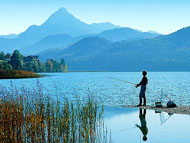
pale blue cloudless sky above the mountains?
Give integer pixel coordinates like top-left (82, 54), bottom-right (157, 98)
top-left (0, 0), bottom-right (190, 35)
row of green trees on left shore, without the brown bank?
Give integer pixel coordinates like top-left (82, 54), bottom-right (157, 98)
top-left (0, 50), bottom-right (67, 72)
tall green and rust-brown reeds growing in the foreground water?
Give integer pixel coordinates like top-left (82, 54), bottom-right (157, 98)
top-left (0, 83), bottom-right (111, 143)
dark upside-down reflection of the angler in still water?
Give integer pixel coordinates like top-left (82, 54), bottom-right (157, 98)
top-left (136, 108), bottom-right (148, 141)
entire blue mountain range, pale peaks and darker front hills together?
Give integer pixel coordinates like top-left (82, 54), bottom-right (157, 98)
top-left (0, 8), bottom-right (190, 71)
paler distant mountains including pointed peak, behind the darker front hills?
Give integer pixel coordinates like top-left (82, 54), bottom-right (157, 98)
top-left (0, 8), bottom-right (162, 55)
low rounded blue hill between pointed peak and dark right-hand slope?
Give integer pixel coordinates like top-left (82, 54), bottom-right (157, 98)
top-left (98, 27), bottom-right (161, 42)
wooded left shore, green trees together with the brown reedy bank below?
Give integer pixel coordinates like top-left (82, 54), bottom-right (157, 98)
top-left (0, 50), bottom-right (68, 79)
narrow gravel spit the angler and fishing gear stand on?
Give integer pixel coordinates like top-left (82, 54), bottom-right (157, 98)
top-left (121, 105), bottom-right (190, 115)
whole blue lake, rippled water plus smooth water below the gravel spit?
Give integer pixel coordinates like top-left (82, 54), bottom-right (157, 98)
top-left (0, 72), bottom-right (190, 143)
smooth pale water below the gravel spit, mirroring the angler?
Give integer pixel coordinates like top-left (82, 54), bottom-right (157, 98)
top-left (105, 107), bottom-right (190, 143)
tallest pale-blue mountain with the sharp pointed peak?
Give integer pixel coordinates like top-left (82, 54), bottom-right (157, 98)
top-left (19, 8), bottom-right (96, 44)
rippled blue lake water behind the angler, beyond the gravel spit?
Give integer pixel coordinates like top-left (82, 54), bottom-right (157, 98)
top-left (0, 72), bottom-right (190, 106)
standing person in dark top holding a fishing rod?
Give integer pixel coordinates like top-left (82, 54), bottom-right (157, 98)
top-left (135, 71), bottom-right (148, 106)
